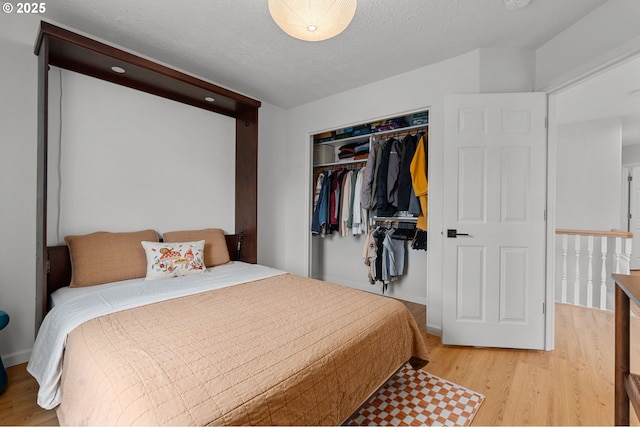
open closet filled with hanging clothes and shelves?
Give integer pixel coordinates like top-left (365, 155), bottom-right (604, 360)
top-left (309, 110), bottom-right (429, 305)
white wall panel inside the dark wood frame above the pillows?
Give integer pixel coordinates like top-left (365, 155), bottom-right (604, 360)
top-left (47, 67), bottom-right (236, 239)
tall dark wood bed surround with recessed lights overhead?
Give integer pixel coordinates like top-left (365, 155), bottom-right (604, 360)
top-left (34, 21), bottom-right (261, 330)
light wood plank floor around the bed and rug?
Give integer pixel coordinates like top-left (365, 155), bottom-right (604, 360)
top-left (0, 303), bottom-right (640, 426)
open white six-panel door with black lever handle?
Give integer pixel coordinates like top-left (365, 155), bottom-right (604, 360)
top-left (442, 93), bottom-right (547, 349)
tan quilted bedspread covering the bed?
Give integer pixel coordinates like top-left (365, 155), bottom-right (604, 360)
top-left (57, 274), bottom-right (428, 425)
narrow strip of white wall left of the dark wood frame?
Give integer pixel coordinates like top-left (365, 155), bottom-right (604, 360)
top-left (0, 14), bottom-right (38, 366)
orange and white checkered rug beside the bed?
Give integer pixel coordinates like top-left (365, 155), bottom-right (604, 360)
top-left (346, 364), bottom-right (484, 426)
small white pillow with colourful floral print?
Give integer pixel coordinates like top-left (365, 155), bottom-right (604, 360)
top-left (142, 240), bottom-right (206, 280)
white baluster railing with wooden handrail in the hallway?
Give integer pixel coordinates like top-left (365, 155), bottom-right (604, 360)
top-left (556, 229), bottom-right (633, 310)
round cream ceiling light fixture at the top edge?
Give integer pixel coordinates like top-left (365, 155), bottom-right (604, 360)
top-left (269, 0), bottom-right (358, 42)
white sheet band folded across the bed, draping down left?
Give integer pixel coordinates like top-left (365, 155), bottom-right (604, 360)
top-left (27, 261), bottom-right (286, 409)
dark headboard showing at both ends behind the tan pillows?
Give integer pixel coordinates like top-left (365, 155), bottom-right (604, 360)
top-left (44, 233), bottom-right (243, 313)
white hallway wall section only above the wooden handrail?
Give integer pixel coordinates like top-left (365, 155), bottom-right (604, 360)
top-left (556, 118), bottom-right (622, 230)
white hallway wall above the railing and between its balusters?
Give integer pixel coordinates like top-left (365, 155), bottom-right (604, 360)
top-left (553, 115), bottom-right (626, 309)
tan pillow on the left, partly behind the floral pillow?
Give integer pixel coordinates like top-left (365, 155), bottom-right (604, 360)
top-left (64, 230), bottom-right (158, 288)
